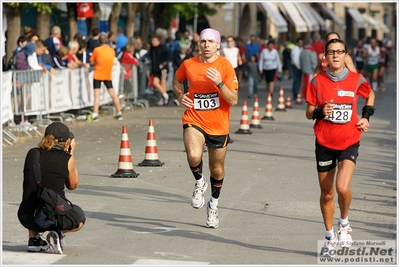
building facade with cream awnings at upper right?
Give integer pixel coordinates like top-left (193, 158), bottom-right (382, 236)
top-left (207, 2), bottom-right (397, 46)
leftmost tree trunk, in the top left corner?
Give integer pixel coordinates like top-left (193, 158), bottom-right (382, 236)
top-left (3, 4), bottom-right (23, 62)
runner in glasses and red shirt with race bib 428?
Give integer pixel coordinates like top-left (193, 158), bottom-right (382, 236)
top-left (306, 39), bottom-right (375, 255)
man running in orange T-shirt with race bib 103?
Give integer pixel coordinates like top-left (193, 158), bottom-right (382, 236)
top-left (173, 28), bottom-right (238, 228)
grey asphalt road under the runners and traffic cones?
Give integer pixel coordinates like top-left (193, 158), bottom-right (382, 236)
top-left (2, 66), bottom-right (397, 266)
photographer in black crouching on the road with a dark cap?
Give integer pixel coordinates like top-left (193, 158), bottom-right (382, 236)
top-left (18, 122), bottom-right (86, 254)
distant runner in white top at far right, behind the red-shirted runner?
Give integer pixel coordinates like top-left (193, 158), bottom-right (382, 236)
top-left (364, 38), bottom-right (380, 92)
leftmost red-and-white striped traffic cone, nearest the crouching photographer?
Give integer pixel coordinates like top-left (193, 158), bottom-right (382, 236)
top-left (111, 126), bottom-right (139, 178)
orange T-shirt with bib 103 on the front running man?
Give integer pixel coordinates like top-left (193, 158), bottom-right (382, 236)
top-left (176, 56), bottom-right (238, 135)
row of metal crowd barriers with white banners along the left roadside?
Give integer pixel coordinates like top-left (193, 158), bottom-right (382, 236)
top-left (2, 61), bottom-right (154, 145)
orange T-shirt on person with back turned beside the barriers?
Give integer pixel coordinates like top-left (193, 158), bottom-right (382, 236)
top-left (90, 44), bottom-right (115, 81)
